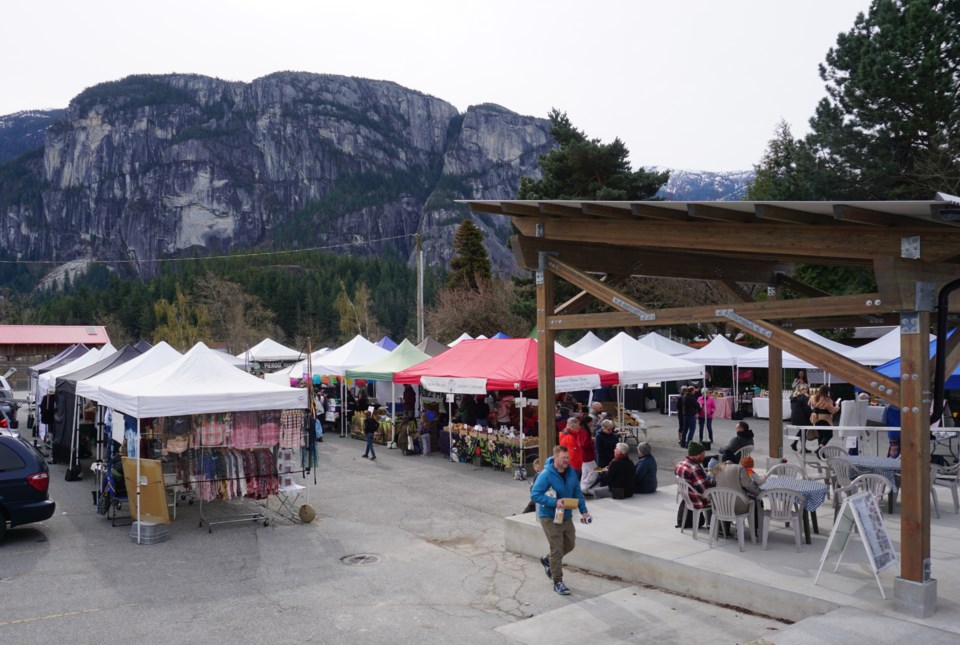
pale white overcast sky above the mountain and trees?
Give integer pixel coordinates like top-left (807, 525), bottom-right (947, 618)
top-left (0, 0), bottom-right (870, 170)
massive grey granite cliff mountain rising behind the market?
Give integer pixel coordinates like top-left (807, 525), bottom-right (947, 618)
top-left (0, 72), bottom-right (553, 275)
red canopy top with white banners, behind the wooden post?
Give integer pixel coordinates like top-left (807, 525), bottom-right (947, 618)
top-left (394, 338), bottom-right (618, 394)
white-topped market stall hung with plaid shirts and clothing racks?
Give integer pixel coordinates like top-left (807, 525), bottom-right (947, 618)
top-left (99, 343), bottom-right (308, 541)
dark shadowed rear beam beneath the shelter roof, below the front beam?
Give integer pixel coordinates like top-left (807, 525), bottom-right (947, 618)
top-left (510, 235), bottom-right (792, 284)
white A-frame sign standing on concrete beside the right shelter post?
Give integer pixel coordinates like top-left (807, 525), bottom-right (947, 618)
top-left (813, 492), bottom-right (897, 600)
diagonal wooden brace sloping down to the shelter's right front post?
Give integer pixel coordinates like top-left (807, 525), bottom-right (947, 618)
top-left (712, 312), bottom-right (900, 400)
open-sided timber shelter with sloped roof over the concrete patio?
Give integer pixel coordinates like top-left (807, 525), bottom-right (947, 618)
top-left (466, 195), bottom-right (960, 612)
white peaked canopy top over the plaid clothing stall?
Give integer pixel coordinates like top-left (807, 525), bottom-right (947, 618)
top-left (99, 343), bottom-right (307, 419)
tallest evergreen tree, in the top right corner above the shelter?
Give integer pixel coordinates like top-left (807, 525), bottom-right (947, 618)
top-left (807, 0), bottom-right (960, 199)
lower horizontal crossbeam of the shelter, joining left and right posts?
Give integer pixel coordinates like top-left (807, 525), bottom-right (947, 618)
top-left (549, 294), bottom-right (886, 330)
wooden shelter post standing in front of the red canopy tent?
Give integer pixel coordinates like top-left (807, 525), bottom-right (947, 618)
top-left (537, 248), bottom-right (557, 464)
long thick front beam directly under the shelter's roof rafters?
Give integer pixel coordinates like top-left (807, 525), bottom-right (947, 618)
top-left (513, 219), bottom-right (960, 264)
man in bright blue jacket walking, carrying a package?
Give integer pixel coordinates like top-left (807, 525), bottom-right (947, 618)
top-left (530, 446), bottom-right (591, 596)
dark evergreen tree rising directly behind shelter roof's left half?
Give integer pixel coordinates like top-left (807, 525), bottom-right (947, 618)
top-left (517, 109), bottom-right (670, 200)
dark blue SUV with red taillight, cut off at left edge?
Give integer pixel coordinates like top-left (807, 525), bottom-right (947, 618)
top-left (0, 435), bottom-right (57, 541)
